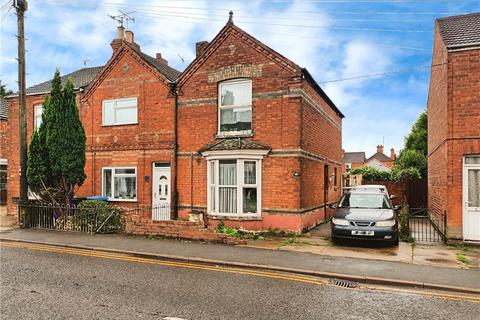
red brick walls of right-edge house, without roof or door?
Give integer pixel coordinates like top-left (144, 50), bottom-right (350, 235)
top-left (428, 22), bottom-right (480, 239)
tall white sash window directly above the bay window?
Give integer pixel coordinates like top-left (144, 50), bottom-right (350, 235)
top-left (218, 79), bottom-right (252, 135)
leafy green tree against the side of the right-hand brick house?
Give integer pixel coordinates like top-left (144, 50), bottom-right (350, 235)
top-left (395, 111), bottom-right (428, 177)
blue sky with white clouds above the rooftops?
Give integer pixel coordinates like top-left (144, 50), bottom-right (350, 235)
top-left (0, 0), bottom-right (480, 156)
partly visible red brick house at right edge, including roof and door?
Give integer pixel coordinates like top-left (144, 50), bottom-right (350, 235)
top-left (428, 13), bottom-right (480, 241)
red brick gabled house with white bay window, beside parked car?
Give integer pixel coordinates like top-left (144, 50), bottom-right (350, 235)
top-left (177, 16), bottom-right (343, 231)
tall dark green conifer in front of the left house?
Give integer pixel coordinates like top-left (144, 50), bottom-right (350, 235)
top-left (27, 70), bottom-right (86, 204)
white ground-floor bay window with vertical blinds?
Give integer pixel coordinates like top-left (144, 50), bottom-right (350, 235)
top-left (207, 158), bottom-right (261, 216)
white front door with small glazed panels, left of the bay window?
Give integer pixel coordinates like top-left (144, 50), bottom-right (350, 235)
top-left (152, 162), bottom-right (171, 220)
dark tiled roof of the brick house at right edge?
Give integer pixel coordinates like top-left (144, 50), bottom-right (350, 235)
top-left (437, 12), bottom-right (480, 48)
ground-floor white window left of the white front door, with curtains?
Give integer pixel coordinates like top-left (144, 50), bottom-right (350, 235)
top-left (102, 167), bottom-right (137, 201)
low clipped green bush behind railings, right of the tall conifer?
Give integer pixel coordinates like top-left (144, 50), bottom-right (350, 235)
top-left (76, 200), bottom-right (123, 233)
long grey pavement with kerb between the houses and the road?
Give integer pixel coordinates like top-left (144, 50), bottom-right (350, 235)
top-left (0, 229), bottom-right (480, 294)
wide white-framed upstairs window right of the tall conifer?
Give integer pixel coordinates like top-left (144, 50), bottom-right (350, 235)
top-left (102, 98), bottom-right (138, 126)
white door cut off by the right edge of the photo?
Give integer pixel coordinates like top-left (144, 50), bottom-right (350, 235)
top-left (462, 156), bottom-right (480, 241)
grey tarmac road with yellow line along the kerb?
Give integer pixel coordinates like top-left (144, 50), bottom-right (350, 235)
top-left (0, 244), bottom-right (480, 320)
